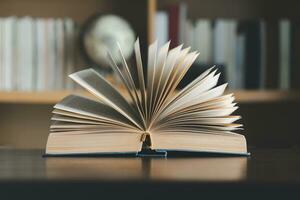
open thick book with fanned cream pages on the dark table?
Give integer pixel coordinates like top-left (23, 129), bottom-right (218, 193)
top-left (46, 40), bottom-right (248, 155)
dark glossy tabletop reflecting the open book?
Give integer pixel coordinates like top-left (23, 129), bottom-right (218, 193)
top-left (0, 149), bottom-right (300, 200)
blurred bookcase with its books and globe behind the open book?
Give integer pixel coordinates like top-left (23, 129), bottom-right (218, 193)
top-left (0, 0), bottom-right (300, 148)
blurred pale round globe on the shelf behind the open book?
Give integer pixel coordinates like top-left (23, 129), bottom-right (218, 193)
top-left (80, 14), bottom-right (135, 70)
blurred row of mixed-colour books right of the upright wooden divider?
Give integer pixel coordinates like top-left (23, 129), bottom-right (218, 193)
top-left (154, 3), bottom-right (300, 89)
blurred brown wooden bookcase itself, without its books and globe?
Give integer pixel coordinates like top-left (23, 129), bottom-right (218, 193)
top-left (0, 0), bottom-right (300, 148)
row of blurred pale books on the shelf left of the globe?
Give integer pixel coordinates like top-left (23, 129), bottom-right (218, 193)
top-left (0, 16), bottom-right (78, 91)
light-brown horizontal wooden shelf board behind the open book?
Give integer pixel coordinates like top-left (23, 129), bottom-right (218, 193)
top-left (0, 90), bottom-right (300, 104)
